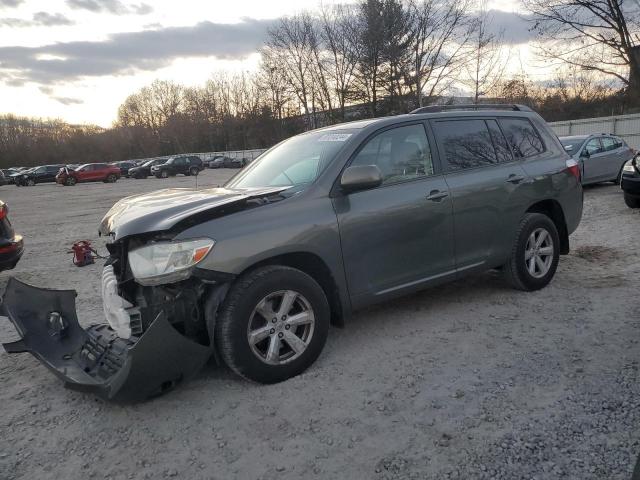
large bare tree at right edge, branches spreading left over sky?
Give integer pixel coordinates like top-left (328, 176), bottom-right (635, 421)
top-left (523, 0), bottom-right (640, 103)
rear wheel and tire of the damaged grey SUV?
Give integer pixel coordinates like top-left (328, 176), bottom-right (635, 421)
top-left (503, 213), bottom-right (560, 291)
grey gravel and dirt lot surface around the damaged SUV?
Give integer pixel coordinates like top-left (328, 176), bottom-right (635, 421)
top-left (0, 170), bottom-right (640, 480)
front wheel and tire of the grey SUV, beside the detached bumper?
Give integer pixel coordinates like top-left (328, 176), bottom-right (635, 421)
top-left (215, 265), bottom-right (330, 383)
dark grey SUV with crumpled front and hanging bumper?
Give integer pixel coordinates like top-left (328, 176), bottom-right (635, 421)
top-left (2, 105), bottom-right (582, 400)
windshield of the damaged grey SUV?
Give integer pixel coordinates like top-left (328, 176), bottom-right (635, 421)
top-left (227, 130), bottom-right (352, 188)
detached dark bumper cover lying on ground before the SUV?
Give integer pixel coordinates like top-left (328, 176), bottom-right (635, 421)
top-left (0, 278), bottom-right (211, 402)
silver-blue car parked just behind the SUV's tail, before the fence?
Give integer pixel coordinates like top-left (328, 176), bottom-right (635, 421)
top-left (560, 133), bottom-right (634, 185)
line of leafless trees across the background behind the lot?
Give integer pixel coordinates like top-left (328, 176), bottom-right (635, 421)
top-left (0, 0), bottom-right (640, 167)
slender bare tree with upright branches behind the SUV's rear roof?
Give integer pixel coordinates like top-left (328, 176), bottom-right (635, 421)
top-left (464, 0), bottom-right (509, 103)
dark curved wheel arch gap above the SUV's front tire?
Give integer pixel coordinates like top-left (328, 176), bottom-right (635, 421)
top-left (240, 251), bottom-right (348, 326)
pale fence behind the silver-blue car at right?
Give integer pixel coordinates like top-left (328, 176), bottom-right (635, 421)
top-left (549, 113), bottom-right (640, 150)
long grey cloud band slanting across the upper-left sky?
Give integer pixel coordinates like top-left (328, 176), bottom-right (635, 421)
top-left (0, 19), bottom-right (274, 85)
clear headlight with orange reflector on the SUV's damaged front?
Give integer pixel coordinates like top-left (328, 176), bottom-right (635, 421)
top-left (129, 238), bottom-right (215, 286)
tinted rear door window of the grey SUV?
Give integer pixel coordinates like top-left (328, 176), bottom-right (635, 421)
top-left (433, 119), bottom-right (498, 171)
